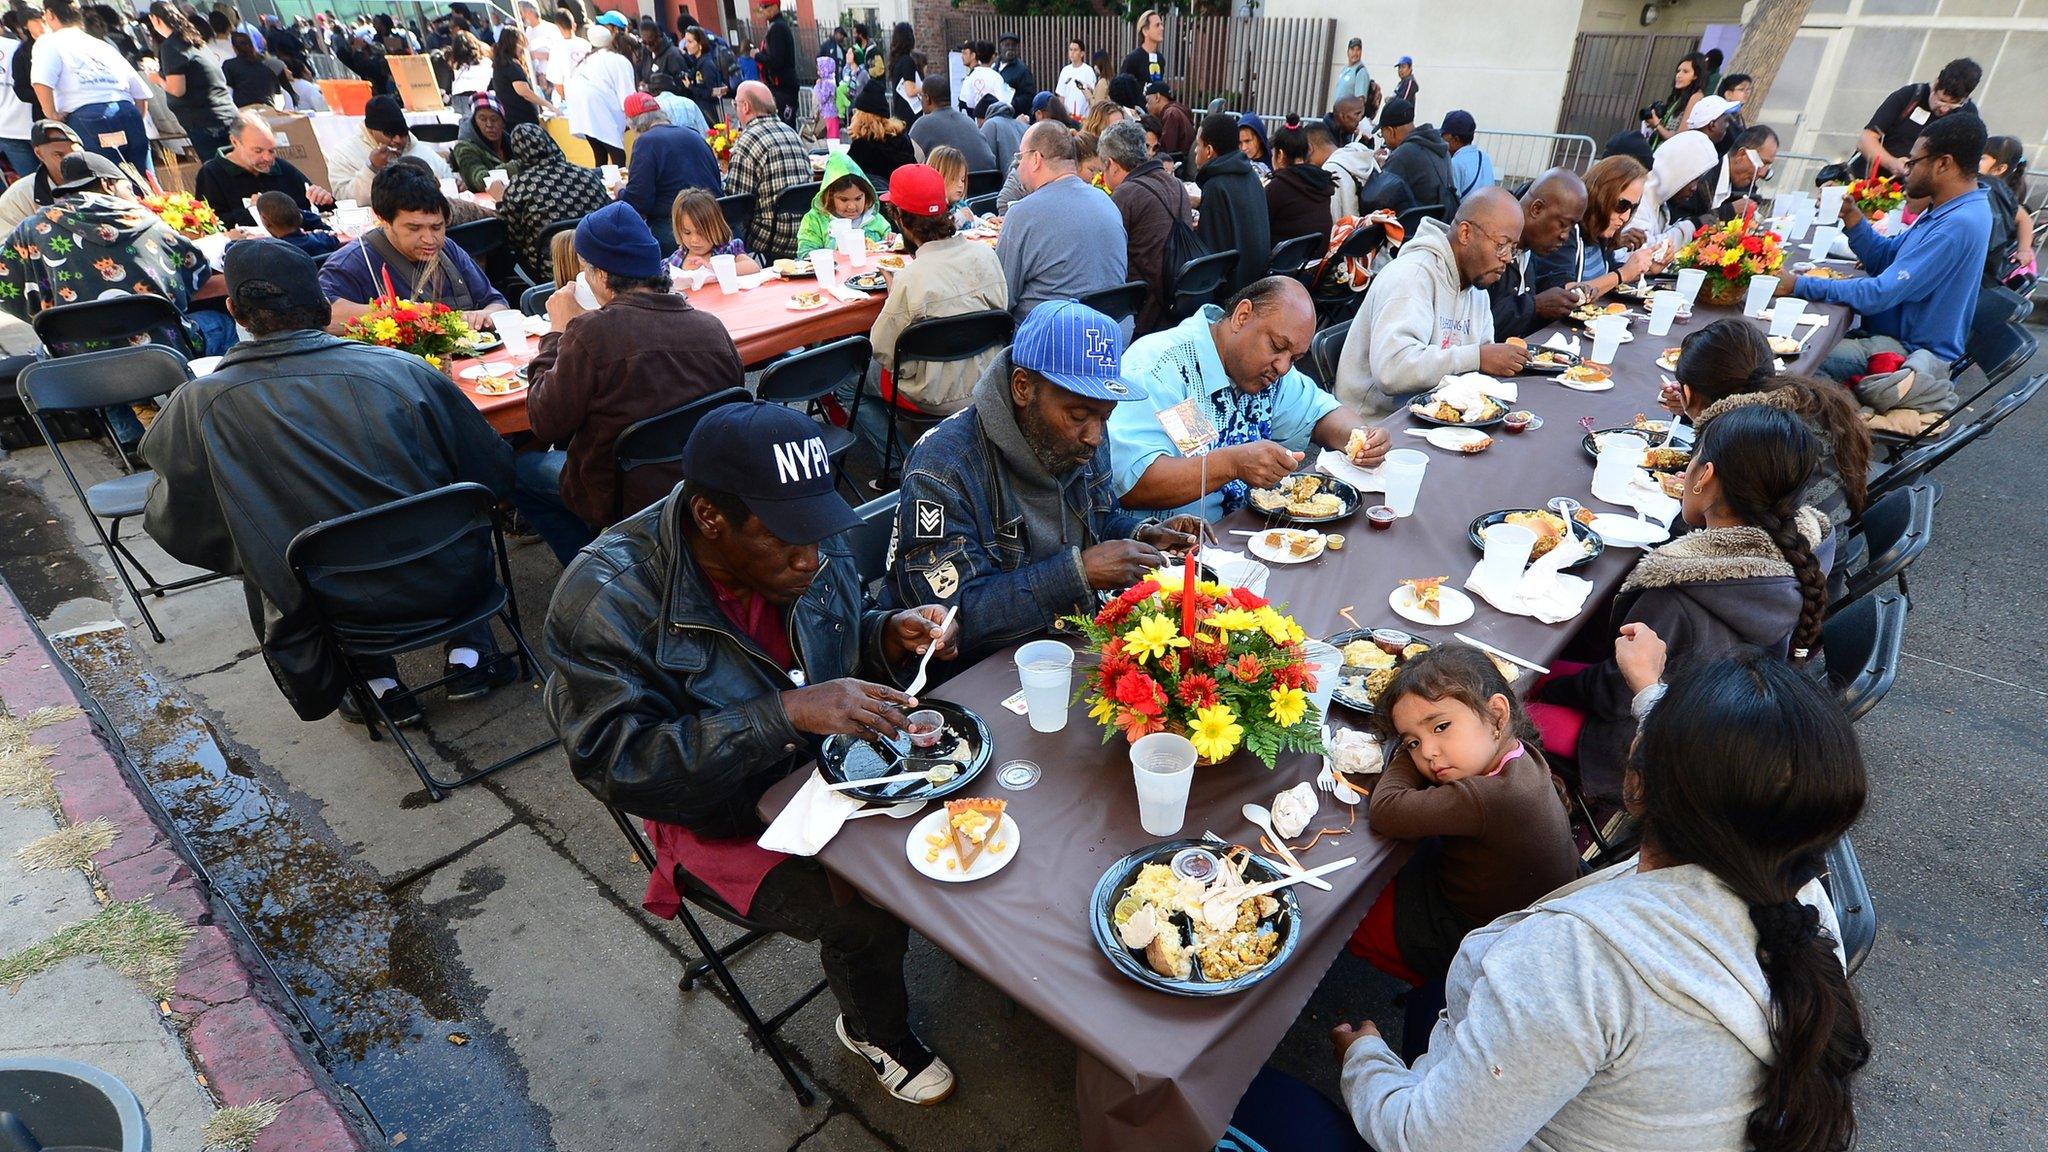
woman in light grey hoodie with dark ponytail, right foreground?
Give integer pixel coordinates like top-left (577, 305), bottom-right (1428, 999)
top-left (1327, 648), bottom-right (1870, 1152)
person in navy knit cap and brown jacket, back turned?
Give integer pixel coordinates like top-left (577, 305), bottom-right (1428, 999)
top-left (512, 203), bottom-right (745, 566)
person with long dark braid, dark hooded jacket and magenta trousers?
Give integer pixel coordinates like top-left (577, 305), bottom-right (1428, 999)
top-left (1530, 404), bottom-right (1835, 804)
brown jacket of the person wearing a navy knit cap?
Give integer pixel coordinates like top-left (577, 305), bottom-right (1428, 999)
top-left (526, 291), bottom-right (745, 529)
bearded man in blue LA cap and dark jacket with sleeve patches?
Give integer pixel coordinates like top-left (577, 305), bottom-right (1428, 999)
top-left (883, 299), bottom-right (1202, 660)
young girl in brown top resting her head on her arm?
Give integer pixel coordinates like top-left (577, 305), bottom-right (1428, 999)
top-left (1352, 644), bottom-right (1579, 986)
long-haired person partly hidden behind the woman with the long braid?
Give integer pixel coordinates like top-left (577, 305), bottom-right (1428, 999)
top-left (1659, 318), bottom-right (1870, 531)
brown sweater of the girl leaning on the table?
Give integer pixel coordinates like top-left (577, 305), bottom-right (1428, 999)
top-left (1370, 746), bottom-right (1579, 924)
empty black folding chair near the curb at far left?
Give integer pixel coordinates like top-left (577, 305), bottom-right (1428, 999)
top-left (14, 344), bottom-right (223, 644)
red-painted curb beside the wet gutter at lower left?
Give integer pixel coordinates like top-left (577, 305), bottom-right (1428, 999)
top-left (0, 582), bottom-right (373, 1152)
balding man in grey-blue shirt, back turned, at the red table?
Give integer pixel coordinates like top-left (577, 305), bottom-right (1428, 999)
top-left (999, 121), bottom-right (1124, 320)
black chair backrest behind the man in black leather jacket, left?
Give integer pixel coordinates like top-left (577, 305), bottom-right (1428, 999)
top-left (285, 482), bottom-right (502, 644)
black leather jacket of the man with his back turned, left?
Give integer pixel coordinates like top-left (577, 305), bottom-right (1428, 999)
top-left (141, 330), bottom-right (512, 719)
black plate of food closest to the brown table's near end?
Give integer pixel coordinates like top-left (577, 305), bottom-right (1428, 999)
top-left (1087, 838), bottom-right (1300, 996)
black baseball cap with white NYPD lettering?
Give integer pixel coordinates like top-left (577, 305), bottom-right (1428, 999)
top-left (682, 400), bottom-right (860, 543)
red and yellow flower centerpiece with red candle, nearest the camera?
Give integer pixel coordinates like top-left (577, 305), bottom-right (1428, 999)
top-left (1067, 564), bottom-right (1323, 769)
